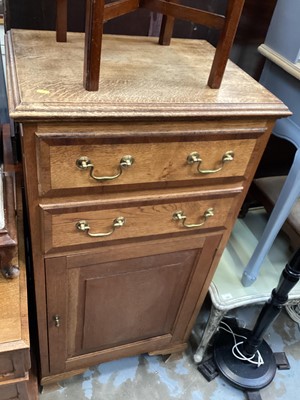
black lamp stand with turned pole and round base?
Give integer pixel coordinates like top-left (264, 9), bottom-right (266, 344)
top-left (214, 249), bottom-right (300, 391)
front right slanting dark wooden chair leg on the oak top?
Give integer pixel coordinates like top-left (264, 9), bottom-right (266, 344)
top-left (208, 0), bottom-right (245, 89)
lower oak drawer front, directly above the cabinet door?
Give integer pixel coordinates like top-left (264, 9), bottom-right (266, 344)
top-left (42, 194), bottom-right (234, 252)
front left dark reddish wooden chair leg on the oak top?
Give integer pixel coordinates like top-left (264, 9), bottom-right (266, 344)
top-left (83, 0), bottom-right (104, 91)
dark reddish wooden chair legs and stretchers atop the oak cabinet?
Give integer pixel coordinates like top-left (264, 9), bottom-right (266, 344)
top-left (56, 0), bottom-right (238, 91)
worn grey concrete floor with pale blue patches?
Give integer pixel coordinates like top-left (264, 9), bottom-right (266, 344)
top-left (40, 211), bottom-right (300, 400)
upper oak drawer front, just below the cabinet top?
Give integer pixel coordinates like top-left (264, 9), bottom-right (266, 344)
top-left (37, 135), bottom-right (256, 196)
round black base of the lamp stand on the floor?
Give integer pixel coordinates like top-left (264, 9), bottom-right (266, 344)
top-left (214, 328), bottom-right (277, 391)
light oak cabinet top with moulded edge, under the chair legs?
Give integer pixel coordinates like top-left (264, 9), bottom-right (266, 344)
top-left (6, 30), bottom-right (289, 121)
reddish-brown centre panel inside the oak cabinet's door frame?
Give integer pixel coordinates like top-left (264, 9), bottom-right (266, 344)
top-left (76, 250), bottom-right (197, 353)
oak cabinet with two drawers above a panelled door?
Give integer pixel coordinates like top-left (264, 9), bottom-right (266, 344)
top-left (7, 31), bottom-right (289, 383)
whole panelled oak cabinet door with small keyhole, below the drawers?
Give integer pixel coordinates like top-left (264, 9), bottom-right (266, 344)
top-left (46, 235), bottom-right (221, 374)
